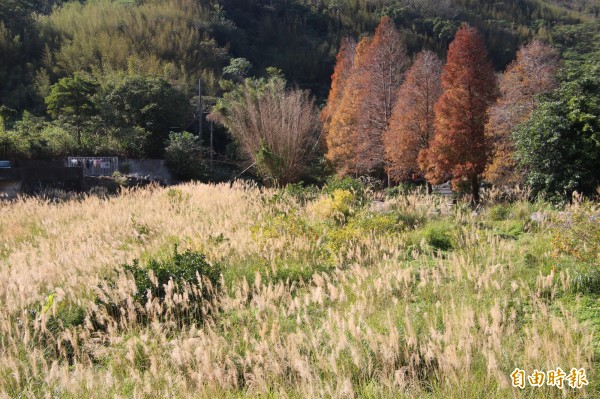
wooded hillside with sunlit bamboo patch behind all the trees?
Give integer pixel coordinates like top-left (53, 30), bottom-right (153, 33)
top-left (0, 0), bottom-right (600, 111)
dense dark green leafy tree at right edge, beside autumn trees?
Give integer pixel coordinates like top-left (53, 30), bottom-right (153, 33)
top-left (515, 58), bottom-right (600, 199)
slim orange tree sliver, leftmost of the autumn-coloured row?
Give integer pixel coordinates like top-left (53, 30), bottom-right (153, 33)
top-left (321, 38), bottom-right (356, 147)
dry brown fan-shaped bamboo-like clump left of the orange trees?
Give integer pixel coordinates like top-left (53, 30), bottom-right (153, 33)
top-left (210, 76), bottom-right (321, 185)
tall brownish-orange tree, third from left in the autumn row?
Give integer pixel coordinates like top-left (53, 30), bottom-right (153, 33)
top-left (356, 17), bottom-right (409, 177)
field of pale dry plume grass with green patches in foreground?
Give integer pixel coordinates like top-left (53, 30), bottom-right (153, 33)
top-left (0, 183), bottom-right (600, 399)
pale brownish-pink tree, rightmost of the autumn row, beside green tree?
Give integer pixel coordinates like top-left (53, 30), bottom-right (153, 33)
top-left (485, 40), bottom-right (560, 185)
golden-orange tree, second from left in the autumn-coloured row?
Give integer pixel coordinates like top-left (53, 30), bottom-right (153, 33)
top-left (325, 38), bottom-right (371, 175)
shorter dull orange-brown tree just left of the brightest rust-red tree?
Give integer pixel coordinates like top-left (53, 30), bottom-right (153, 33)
top-left (383, 51), bottom-right (443, 181)
